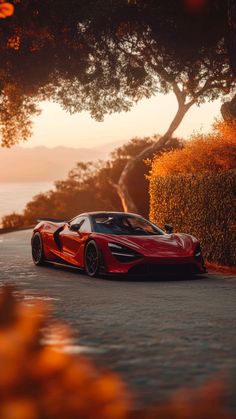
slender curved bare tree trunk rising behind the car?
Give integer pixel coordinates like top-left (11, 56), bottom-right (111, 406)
top-left (116, 102), bottom-right (193, 213)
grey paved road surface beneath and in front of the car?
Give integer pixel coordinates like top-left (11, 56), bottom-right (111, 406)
top-left (0, 231), bottom-right (236, 408)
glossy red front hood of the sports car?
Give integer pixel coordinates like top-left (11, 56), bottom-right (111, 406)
top-left (104, 233), bottom-right (197, 258)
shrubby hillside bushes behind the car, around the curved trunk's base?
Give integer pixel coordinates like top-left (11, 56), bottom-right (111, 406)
top-left (2, 137), bottom-right (157, 228)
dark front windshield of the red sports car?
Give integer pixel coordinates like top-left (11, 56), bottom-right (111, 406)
top-left (92, 214), bottom-right (164, 236)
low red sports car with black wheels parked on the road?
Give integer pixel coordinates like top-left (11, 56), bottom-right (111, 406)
top-left (31, 212), bottom-right (205, 276)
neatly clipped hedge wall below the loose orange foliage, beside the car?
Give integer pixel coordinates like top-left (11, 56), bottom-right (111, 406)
top-left (150, 170), bottom-right (236, 266)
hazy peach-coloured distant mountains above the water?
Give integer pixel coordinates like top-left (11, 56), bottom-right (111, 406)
top-left (0, 141), bottom-right (127, 183)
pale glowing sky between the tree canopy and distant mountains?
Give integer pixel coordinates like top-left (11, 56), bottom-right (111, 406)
top-left (25, 94), bottom-right (221, 148)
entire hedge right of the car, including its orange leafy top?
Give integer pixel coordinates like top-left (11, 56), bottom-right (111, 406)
top-left (150, 121), bottom-right (236, 266)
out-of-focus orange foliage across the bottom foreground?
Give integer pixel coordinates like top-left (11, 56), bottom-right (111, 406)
top-left (0, 287), bottom-right (233, 419)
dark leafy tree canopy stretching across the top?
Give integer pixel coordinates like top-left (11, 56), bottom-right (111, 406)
top-left (0, 0), bottom-right (234, 146)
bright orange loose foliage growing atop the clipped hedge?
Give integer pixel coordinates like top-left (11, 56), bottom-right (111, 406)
top-left (151, 121), bottom-right (236, 177)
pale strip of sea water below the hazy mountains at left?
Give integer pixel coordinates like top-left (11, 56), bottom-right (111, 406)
top-left (0, 182), bottom-right (53, 225)
